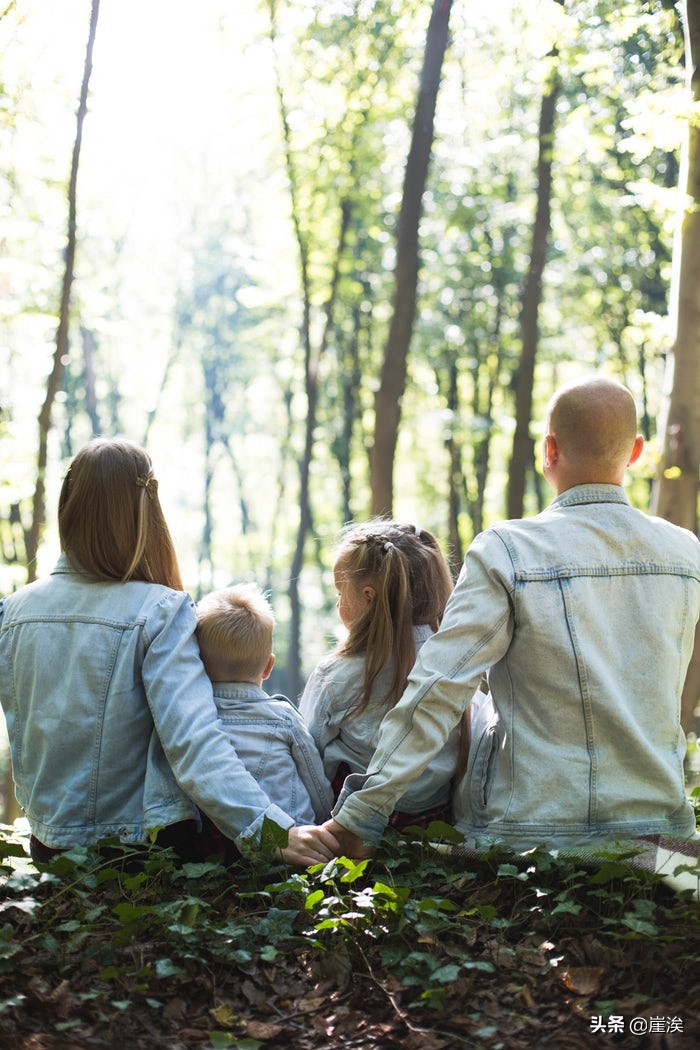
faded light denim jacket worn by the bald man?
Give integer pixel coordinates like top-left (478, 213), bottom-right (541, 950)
top-left (335, 485), bottom-right (700, 848)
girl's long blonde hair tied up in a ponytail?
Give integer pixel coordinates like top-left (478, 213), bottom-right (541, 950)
top-left (336, 518), bottom-right (453, 717)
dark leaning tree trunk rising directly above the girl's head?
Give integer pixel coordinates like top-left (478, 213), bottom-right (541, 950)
top-left (369, 0), bottom-right (452, 515)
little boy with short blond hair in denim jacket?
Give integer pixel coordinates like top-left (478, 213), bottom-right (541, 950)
top-left (197, 584), bottom-right (333, 824)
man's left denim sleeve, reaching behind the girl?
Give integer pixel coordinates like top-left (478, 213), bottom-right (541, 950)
top-left (334, 532), bottom-right (513, 841)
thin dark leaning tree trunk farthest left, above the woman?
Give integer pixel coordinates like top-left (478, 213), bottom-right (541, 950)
top-left (26, 0), bottom-right (100, 581)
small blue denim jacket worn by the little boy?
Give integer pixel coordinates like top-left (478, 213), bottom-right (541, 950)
top-left (214, 681), bottom-right (333, 824)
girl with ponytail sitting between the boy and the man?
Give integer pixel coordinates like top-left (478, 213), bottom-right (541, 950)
top-left (300, 519), bottom-right (468, 827)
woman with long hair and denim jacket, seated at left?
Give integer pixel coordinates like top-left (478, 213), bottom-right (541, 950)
top-left (0, 438), bottom-right (337, 864)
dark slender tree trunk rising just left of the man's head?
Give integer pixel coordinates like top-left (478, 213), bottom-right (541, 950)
top-left (507, 48), bottom-right (561, 518)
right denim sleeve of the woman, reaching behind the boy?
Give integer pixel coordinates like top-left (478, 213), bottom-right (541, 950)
top-left (142, 591), bottom-right (294, 852)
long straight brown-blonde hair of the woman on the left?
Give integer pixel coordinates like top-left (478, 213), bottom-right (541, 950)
top-left (59, 438), bottom-right (184, 590)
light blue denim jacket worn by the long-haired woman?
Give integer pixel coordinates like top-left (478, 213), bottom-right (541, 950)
top-left (0, 555), bottom-right (294, 849)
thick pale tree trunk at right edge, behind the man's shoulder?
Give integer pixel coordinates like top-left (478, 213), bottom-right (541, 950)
top-left (652, 0), bottom-right (700, 732)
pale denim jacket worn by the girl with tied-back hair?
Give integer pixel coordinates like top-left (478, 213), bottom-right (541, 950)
top-left (299, 625), bottom-right (460, 814)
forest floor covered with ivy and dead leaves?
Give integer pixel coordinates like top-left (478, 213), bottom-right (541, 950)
top-left (0, 826), bottom-right (700, 1050)
